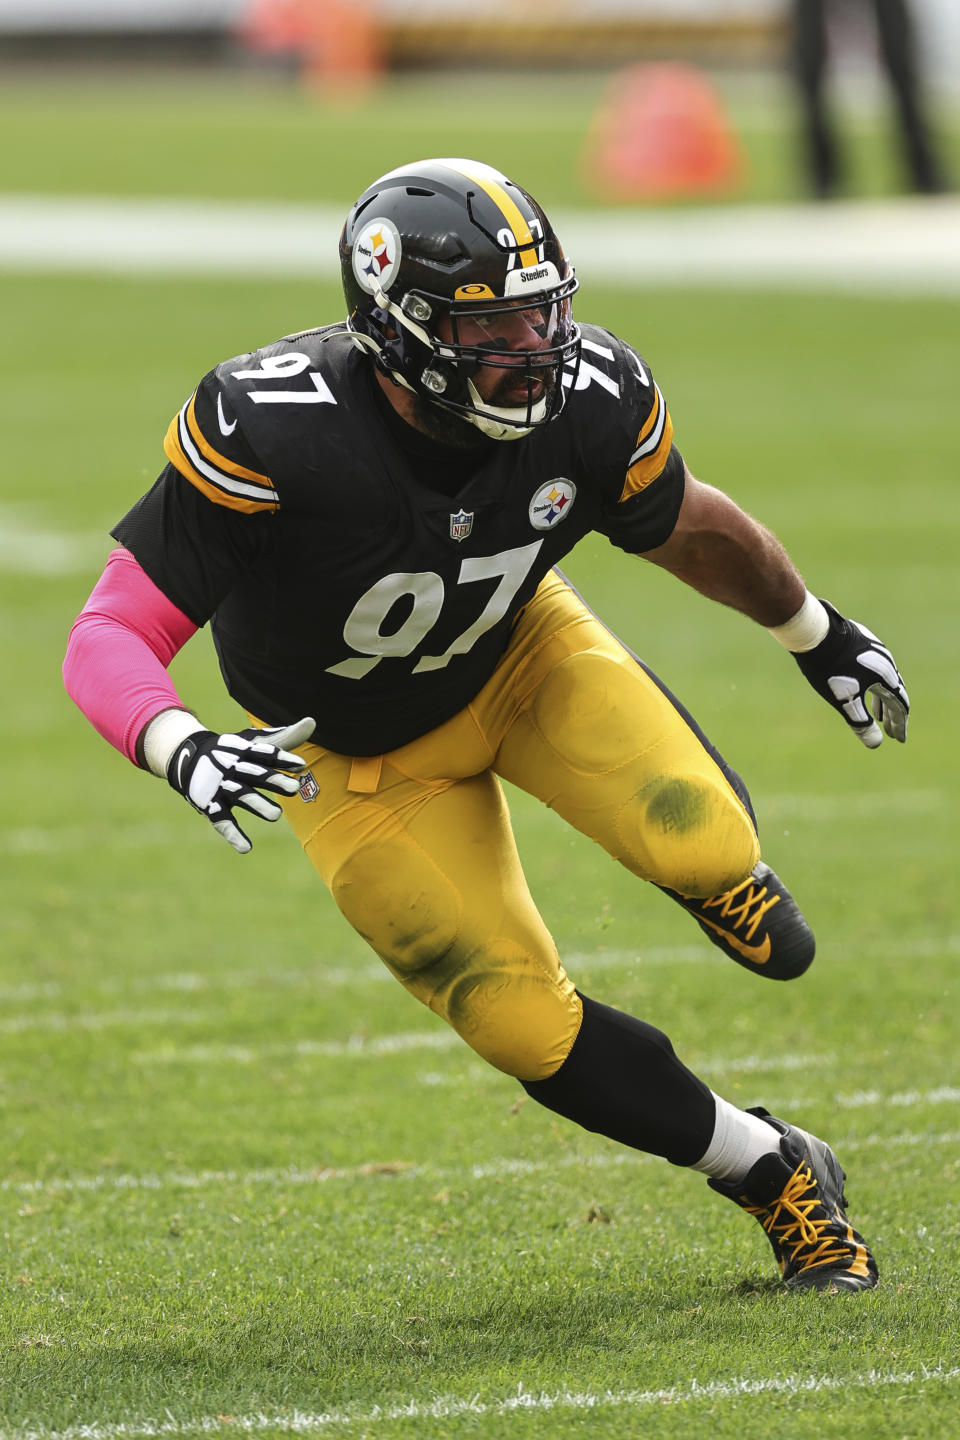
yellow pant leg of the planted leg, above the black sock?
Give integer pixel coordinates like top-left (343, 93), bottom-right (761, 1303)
top-left (273, 714), bottom-right (581, 1079)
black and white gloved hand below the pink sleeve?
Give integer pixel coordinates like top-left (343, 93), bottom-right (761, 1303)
top-left (167, 719), bottom-right (314, 855)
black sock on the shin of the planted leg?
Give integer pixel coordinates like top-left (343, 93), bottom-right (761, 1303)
top-left (521, 995), bottom-right (715, 1165)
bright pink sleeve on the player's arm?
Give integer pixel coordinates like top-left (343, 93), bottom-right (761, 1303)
top-left (63, 547), bottom-right (197, 765)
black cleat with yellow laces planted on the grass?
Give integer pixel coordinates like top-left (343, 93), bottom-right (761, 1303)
top-left (707, 1107), bottom-right (878, 1293)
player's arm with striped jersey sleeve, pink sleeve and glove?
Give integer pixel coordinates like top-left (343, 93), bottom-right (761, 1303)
top-left (63, 365), bottom-right (314, 854)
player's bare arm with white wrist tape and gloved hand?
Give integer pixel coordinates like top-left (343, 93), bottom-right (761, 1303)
top-left (643, 469), bottom-right (910, 749)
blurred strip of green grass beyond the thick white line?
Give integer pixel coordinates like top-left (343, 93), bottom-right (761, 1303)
top-left (0, 71), bottom-right (960, 210)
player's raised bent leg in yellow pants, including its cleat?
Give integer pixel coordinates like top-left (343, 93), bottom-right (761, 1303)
top-left (483, 577), bottom-right (815, 979)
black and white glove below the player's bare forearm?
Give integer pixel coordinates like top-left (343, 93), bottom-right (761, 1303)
top-left (793, 600), bottom-right (910, 750)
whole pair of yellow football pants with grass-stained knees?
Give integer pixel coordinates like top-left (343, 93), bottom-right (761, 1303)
top-left (273, 575), bottom-right (760, 1080)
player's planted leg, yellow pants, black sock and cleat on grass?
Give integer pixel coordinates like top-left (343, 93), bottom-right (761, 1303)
top-left (269, 710), bottom-right (875, 1289)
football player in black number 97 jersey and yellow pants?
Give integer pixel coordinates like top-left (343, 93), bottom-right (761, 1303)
top-left (65, 160), bottom-right (908, 1290)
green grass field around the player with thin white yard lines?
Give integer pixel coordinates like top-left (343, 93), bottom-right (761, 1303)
top-left (0, 64), bottom-right (960, 1440)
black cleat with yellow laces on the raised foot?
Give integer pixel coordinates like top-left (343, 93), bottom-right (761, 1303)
top-left (661, 860), bottom-right (816, 981)
